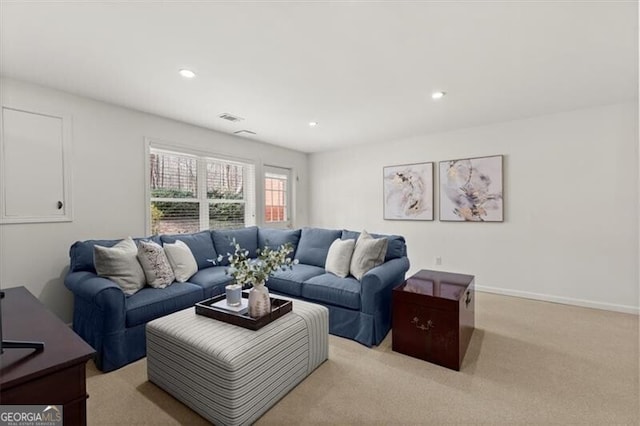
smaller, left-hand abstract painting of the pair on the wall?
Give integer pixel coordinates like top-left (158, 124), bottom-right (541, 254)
top-left (382, 162), bottom-right (434, 220)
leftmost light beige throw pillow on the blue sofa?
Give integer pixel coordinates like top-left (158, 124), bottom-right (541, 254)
top-left (93, 237), bottom-right (145, 294)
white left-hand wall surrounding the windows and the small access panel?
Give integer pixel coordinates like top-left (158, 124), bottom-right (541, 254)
top-left (0, 79), bottom-right (308, 322)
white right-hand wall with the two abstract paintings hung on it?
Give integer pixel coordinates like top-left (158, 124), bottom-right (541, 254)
top-left (309, 103), bottom-right (638, 313)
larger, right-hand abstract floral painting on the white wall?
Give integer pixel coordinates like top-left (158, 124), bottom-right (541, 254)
top-left (439, 155), bottom-right (504, 222)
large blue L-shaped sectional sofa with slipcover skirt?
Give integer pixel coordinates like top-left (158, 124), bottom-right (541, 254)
top-left (65, 226), bottom-right (409, 371)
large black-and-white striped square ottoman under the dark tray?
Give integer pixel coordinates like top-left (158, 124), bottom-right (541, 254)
top-left (147, 300), bottom-right (329, 425)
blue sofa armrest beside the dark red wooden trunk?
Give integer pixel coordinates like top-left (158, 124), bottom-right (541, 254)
top-left (360, 256), bottom-right (409, 314)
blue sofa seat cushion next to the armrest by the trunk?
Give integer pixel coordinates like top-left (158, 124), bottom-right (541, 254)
top-left (302, 273), bottom-right (360, 310)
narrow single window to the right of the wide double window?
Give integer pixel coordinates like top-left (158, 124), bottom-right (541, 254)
top-left (264, 166), bottom-right (291, 226)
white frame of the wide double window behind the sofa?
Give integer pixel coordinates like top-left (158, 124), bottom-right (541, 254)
top-left (144, 138), bottom-right (257, 235)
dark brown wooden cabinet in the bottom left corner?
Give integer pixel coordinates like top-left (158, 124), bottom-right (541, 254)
top-left (0, 287), bottom-right (95, 425)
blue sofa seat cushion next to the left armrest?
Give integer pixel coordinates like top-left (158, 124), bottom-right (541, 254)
top-left (125, 283), bottom-right (204, 327)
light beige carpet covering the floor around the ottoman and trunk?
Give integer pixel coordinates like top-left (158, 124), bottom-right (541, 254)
top-left (87, 293), bottom-right (640, 425)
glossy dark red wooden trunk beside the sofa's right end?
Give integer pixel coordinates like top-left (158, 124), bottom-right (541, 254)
top-left (392, 270), bottom-right (475, 370)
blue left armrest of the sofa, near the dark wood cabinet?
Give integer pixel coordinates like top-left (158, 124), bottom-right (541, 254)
top-left (64, 271), bottom-right (126, 337)
